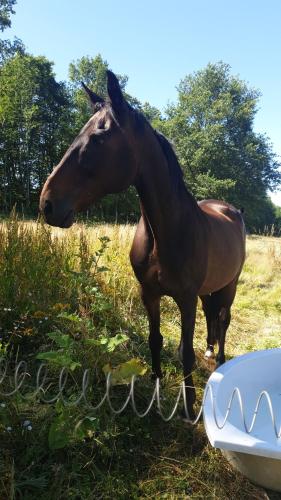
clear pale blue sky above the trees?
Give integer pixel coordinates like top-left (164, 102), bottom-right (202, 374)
top-left (3, 0), bottom-right (281, 206)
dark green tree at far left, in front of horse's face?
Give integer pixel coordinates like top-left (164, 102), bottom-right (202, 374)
top-left (0, 54), bottom-right (71, 211)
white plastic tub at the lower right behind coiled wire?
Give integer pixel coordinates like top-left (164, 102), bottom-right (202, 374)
top-left (203, 349), bottom-right (281, 491)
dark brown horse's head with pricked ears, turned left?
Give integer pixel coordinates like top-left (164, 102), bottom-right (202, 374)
top-left (40, 71), bottom-right (137, 227)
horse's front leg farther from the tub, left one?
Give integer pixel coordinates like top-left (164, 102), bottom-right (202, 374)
top-left (142, 288), bottom-right (163, 379)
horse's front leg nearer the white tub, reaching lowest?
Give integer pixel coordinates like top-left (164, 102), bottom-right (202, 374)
top-left (176, 296), bottom-right (197, 420)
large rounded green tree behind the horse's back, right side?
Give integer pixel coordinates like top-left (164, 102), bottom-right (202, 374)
top-left (159, 63), bottom-right (280, 228)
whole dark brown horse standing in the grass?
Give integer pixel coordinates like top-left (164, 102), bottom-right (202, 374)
top-left (40, 71), bottom-right (245, 417)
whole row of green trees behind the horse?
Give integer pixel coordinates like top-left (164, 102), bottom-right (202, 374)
top-left (0, 0), bottom-right (281, 231)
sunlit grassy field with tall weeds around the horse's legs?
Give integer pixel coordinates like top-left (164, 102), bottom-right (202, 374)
top-left (0, 218), bottom-right (281, 500)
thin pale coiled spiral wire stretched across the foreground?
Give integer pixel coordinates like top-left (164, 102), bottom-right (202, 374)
top-left (0, 359), bottom-right (281, 439)
